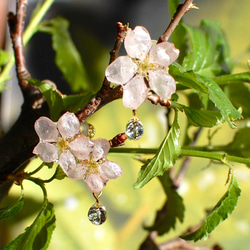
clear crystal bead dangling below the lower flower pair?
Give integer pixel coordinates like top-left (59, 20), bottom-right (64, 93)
top-left (88, 203), bottom-right (107, 225)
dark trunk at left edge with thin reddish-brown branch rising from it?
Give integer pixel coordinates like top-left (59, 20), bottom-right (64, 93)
top-left (0, 0), bottom-right (49, 191)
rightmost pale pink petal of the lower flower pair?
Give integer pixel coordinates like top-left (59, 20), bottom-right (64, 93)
top-left (100, 160), bottom-right (122, 179)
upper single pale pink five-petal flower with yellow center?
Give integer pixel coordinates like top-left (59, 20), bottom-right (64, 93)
top-left (105, 26), bottom-right (179, 110)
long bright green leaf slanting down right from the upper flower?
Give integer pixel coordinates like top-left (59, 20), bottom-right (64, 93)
top-left (170, 63), bottom-right (242, 128)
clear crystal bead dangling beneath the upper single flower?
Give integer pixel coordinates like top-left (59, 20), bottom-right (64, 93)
top-left (125, 117), bottom-right (143, 140)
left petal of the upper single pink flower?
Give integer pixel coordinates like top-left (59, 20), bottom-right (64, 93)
top-left (105, 56), bottom-right (137, 85)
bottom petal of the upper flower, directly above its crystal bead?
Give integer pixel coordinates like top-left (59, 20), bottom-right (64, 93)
top-left (123, 75), bottom-right (148, 110)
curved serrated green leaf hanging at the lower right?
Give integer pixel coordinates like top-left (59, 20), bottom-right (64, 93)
top-left (181, 175), bottom-right (241, 241)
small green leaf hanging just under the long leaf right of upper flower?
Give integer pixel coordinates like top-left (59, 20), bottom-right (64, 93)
top-left (183, 106), bottom-right (224, 128)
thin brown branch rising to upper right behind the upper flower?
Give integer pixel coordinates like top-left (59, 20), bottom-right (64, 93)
top-left (158, 0), bottom-right (193, 43)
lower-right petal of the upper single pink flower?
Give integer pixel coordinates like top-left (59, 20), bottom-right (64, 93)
top-left (149, 70), bottom-right (176, 99)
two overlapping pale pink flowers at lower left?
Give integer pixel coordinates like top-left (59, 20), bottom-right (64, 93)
top-left (33, 112), bottom-right (122, 193)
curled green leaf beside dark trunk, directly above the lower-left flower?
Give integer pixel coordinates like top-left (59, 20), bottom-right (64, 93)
top-left (28, 79), bottom-right (64, 121)
